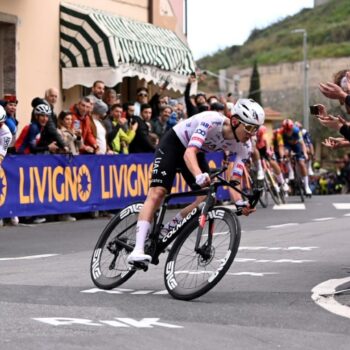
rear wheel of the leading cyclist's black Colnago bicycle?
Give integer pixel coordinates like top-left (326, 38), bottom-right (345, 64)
top-left (90, 203), bottom-right (143, 289)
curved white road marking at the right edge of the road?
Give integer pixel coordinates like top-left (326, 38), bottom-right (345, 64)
top-left (311, 277), bottom-right (350, 318)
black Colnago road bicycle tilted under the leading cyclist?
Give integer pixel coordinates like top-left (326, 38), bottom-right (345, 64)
top-left (90, 167), bottom-right (261, 300)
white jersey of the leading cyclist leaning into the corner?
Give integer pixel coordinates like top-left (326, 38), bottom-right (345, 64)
top-left (173, 111), bottom-right (252, 176)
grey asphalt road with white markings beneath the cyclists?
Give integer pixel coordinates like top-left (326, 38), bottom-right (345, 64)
top-left (0, 196), bottom-right (350, 350)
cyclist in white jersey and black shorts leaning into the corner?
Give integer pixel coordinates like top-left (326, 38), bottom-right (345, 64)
top-left (128, 99), bottom-right (265, 264)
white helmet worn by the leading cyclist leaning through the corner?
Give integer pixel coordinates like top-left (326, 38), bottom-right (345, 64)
top-left (234, 98), bottom-right (265, 125)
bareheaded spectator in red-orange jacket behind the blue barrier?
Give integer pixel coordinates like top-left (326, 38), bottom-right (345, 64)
top-left (70, 97), bottom-right (98, 154)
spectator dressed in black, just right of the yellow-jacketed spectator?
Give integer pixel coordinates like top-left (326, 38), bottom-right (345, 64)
top-left (129, 104), bottom-right (155, 153)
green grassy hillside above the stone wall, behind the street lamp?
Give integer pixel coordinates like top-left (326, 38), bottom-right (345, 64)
top-left (197, 0), bottom-right (350, 72)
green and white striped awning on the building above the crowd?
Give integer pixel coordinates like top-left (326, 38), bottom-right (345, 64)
top-left (60, 3), bottom-right (195, 90)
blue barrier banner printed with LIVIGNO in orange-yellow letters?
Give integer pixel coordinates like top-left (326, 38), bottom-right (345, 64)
top-left (0, 153), bottom-right (232, 218)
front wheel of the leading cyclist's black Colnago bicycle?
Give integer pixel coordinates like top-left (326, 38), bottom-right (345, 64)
top-left (164, 207), bottom-right (241, 300)
